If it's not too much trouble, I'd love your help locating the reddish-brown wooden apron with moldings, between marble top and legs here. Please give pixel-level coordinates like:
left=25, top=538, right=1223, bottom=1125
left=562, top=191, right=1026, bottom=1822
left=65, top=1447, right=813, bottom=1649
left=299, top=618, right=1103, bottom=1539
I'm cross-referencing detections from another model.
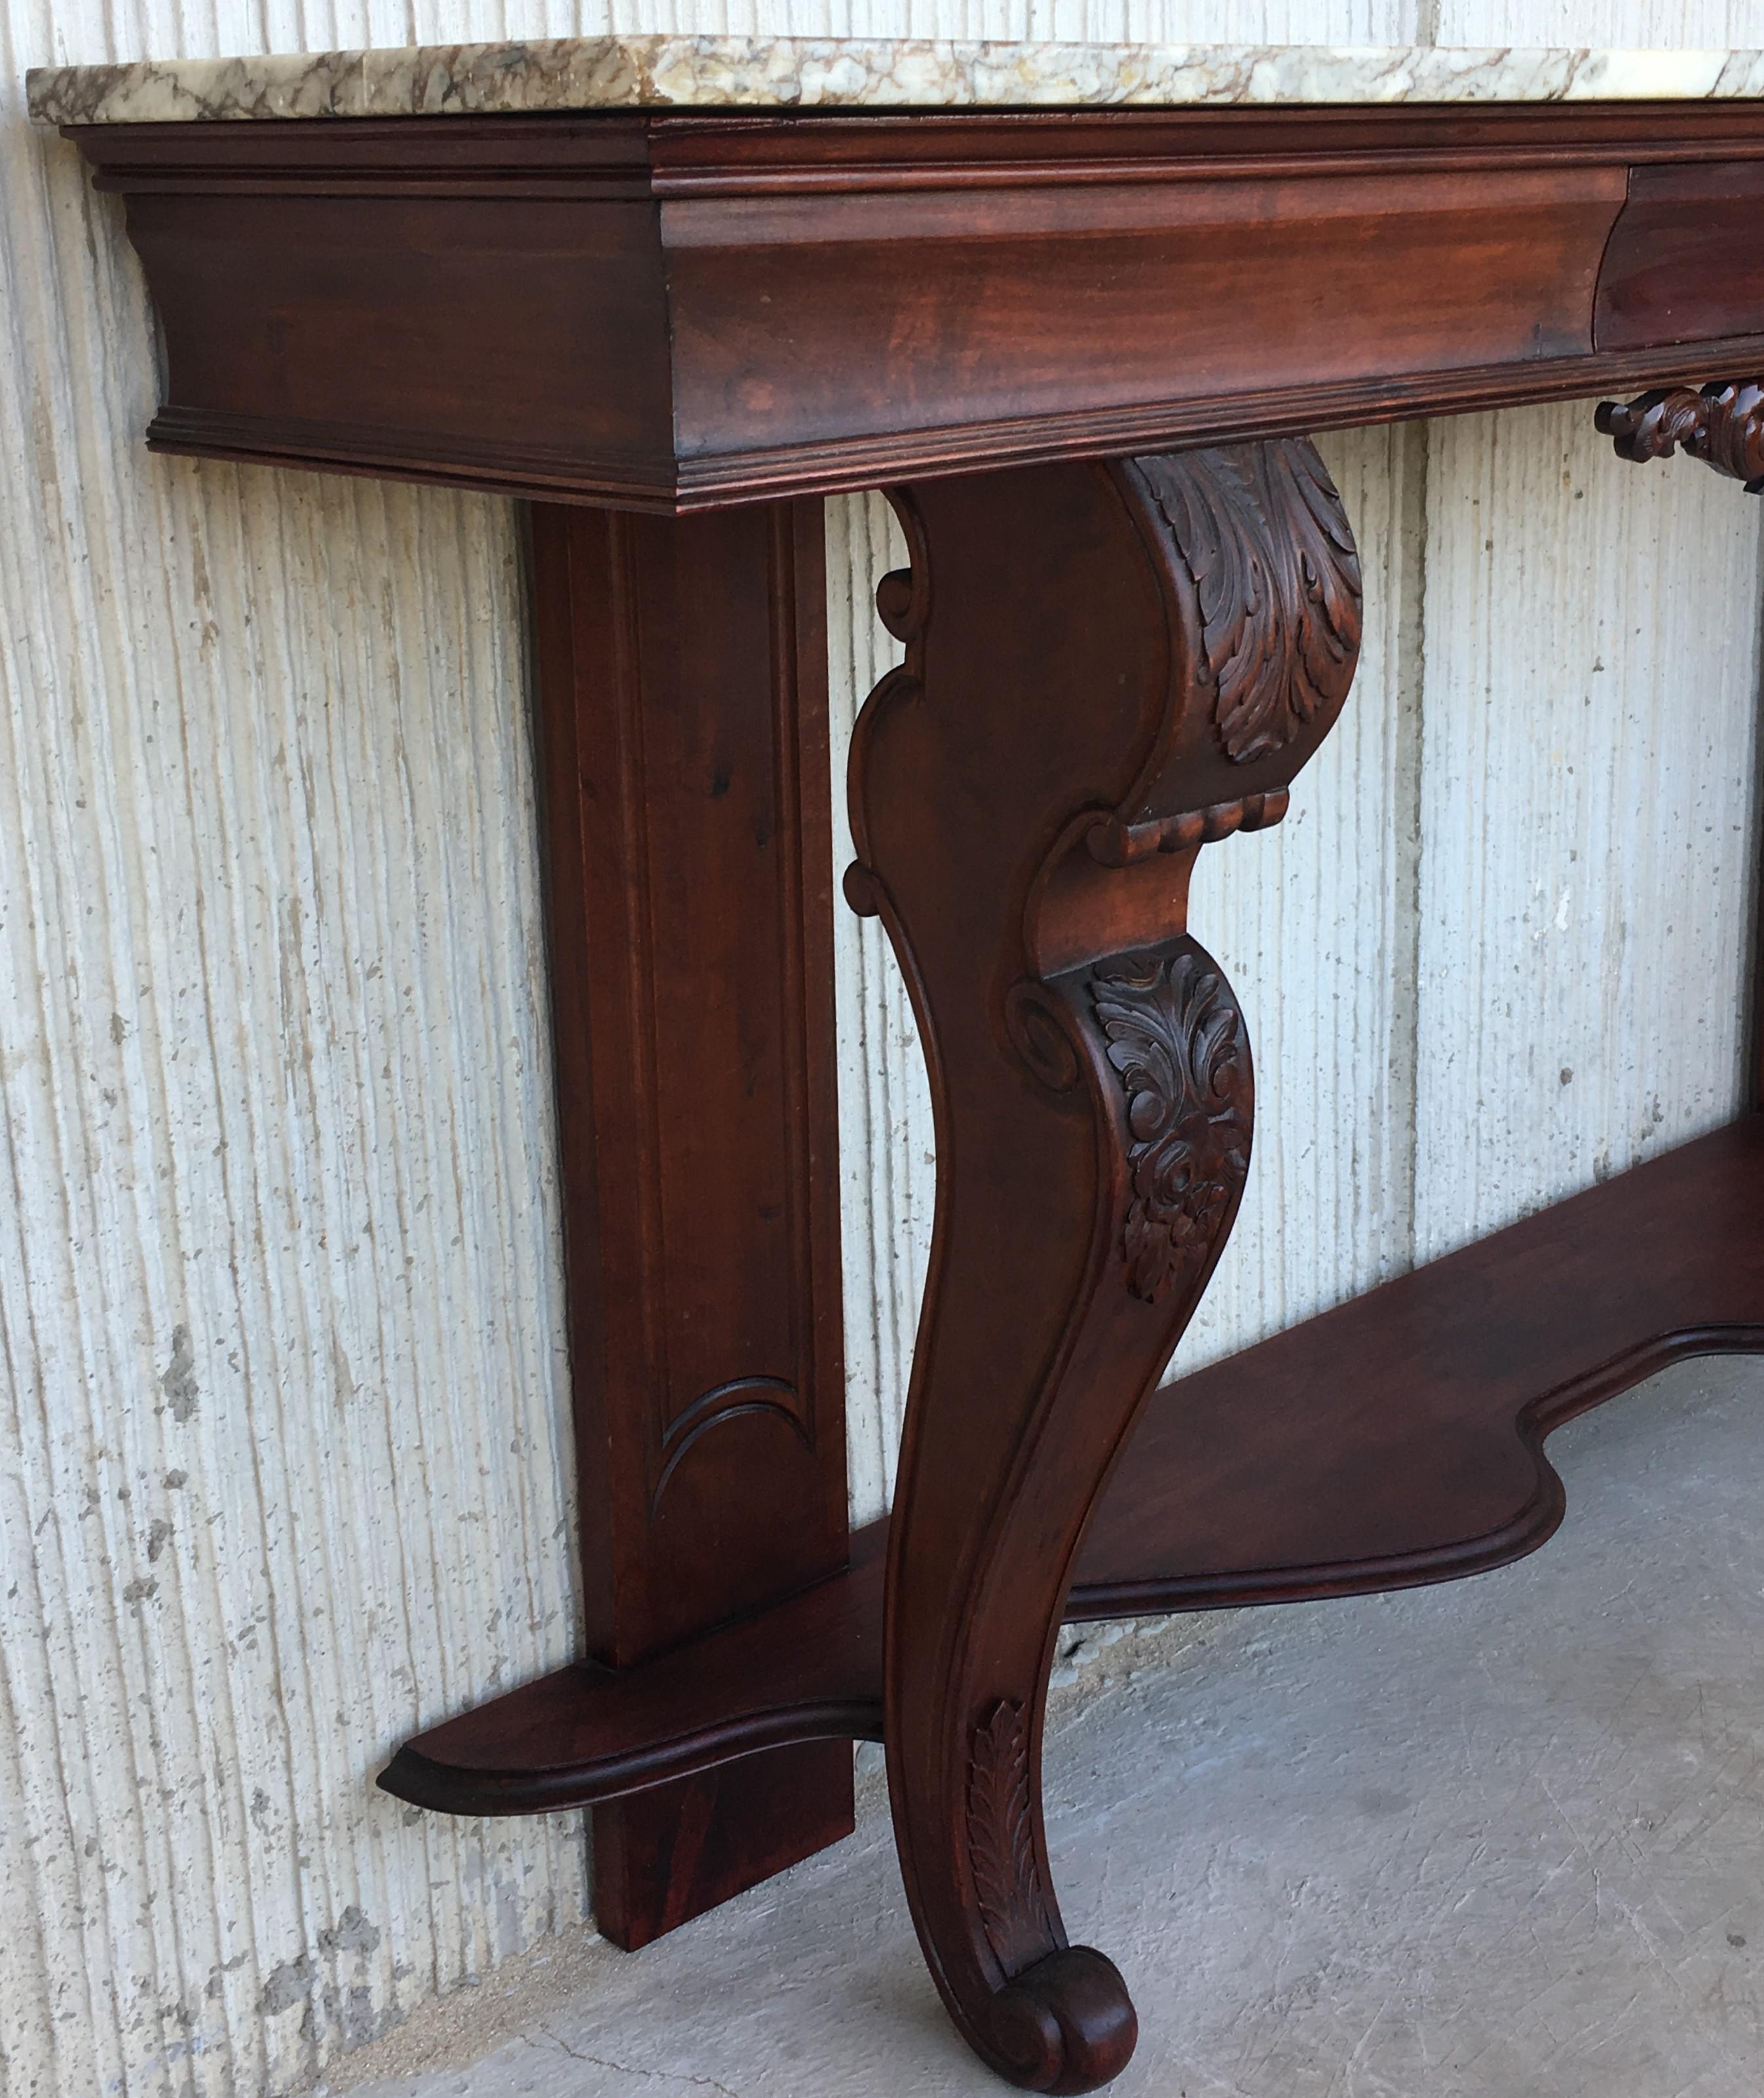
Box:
left=71, top=103, right=1764, bottom=508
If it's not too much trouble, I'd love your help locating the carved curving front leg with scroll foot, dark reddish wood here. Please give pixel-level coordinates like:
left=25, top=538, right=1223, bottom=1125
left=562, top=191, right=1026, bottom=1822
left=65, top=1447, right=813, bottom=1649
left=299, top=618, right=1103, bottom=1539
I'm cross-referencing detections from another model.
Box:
left=848, top=440, right=1359, bottom=2091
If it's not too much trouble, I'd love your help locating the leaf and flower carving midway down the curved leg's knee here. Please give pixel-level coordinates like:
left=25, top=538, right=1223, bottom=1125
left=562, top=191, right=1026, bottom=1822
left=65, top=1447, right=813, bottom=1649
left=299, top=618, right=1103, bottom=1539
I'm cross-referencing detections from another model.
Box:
left=1091, top=948, right=1250, bottom=1303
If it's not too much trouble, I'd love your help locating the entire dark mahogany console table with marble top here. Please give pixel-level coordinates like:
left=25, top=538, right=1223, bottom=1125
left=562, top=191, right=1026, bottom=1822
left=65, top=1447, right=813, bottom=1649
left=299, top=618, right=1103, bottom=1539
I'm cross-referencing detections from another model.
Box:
left=33, top=38, right=1764, bottom=2091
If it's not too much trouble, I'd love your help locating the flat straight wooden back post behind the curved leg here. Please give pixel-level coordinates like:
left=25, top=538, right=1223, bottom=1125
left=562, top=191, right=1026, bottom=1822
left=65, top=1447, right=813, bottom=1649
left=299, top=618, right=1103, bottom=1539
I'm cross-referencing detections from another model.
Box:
left=522, top=501, right=852, bottom=1945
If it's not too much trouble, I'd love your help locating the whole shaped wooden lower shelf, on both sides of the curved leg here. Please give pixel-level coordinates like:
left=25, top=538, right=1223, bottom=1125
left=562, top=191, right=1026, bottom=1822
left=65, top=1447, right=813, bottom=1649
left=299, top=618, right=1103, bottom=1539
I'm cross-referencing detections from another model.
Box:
left=380, top=1114, right=1764, bottom=1815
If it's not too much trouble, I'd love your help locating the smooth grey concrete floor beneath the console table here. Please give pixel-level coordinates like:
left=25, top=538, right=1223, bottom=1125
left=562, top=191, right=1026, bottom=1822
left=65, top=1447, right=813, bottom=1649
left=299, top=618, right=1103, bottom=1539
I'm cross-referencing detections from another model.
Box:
left=329, top=1362, right=1764, bottom=2098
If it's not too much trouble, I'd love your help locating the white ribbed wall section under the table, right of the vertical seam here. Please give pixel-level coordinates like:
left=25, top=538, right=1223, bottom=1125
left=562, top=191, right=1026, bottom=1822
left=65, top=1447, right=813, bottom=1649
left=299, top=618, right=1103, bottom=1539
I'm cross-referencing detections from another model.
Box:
left=1416, top=405, right=1760, bottom=1257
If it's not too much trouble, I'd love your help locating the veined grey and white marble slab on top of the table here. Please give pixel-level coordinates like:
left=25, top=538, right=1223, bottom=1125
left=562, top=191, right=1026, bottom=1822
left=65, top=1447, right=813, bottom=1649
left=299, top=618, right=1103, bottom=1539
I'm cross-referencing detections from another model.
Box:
left=29, top=35, right=1764, bottom=124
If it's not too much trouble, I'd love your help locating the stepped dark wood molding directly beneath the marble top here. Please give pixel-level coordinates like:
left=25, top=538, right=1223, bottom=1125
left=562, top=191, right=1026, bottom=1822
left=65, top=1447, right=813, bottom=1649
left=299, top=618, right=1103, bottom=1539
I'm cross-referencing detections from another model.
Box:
left=59, top=101, right=1764, bottom=201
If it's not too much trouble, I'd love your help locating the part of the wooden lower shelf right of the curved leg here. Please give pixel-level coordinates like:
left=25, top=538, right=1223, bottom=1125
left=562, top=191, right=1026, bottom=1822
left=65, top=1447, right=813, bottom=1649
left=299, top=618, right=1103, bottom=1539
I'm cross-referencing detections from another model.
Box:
left=1078, top=1116, right=1764, bottom=1616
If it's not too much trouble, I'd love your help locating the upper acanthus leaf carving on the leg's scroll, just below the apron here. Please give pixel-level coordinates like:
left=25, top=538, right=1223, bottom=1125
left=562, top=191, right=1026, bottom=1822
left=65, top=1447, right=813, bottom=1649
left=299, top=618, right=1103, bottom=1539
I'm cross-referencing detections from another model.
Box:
left=1137, top=436, right=1359, bottom=764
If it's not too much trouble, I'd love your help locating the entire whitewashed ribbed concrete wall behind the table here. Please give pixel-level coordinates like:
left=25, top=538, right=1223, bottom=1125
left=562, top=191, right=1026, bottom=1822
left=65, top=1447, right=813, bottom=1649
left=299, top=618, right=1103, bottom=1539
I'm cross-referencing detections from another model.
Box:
left=0, top=0, right=1760, bottom=2098
